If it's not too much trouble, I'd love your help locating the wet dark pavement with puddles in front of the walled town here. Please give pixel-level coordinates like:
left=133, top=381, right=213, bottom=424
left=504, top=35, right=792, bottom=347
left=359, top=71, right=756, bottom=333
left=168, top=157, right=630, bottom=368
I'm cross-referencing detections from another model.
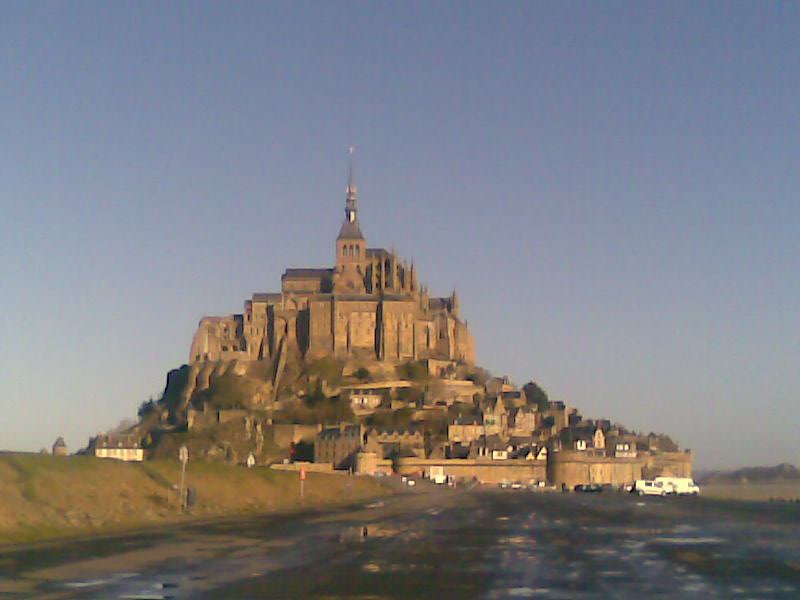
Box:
left=0, top=490, right=800, bottom=600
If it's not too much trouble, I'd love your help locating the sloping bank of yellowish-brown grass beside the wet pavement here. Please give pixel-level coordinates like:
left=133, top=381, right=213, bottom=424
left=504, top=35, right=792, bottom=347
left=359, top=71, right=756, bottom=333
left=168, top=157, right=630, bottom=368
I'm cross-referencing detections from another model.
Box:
left=0, top=454, right=388, bottom=544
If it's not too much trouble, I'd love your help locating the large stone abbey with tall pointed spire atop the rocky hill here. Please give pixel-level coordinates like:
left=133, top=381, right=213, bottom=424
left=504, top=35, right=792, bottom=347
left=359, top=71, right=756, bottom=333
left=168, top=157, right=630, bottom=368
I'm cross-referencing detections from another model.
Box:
left=189, top=168, right=474, bottom=363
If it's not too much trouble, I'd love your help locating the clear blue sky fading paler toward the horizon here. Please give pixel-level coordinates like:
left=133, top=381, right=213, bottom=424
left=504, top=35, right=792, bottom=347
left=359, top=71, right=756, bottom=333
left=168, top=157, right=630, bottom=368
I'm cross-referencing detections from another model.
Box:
left=0, top=2, right=800, bottom=467
